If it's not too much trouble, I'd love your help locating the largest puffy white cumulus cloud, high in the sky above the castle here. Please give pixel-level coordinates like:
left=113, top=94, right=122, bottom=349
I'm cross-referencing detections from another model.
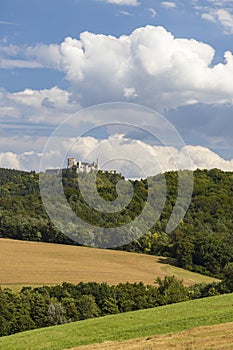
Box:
left=0, top=26, right=233, bottom=112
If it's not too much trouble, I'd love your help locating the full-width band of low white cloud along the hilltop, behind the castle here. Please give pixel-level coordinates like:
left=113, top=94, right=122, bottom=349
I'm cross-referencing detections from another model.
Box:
left=0, top=135, right=233, bottom=178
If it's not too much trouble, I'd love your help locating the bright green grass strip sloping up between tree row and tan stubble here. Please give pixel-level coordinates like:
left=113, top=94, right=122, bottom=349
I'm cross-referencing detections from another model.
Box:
left=0, top=294, right=233, bottom=350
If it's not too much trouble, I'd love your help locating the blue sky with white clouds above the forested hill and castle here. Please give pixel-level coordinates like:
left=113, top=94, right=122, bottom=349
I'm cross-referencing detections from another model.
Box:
left=0, top=0, right=233, bottom=177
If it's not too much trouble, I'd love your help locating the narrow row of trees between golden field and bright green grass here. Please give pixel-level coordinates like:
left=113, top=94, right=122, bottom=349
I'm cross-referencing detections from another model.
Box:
left=0, top=272, right=233, bottom=336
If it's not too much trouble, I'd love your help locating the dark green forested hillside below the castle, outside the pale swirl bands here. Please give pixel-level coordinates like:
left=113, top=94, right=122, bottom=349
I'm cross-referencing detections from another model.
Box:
left=0, top=169, right=233, bottom=277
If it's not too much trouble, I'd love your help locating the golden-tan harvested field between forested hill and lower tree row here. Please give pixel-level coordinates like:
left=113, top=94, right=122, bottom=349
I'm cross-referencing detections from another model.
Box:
left=0, top=239, right=217, bottom=289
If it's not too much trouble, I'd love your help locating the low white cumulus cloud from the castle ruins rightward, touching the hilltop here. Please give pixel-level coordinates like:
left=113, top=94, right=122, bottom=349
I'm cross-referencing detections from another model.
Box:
left=71, top=135, right=233, bottom=177
